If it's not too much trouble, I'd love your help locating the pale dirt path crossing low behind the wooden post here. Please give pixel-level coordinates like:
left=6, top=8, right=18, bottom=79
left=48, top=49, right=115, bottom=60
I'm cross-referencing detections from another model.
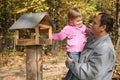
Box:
left=0, top=62, right=67, bottom=80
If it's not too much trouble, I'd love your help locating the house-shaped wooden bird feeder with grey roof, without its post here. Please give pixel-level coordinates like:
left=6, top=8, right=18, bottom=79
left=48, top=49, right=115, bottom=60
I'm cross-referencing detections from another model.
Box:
left=10, top=12, right=54, bottom=46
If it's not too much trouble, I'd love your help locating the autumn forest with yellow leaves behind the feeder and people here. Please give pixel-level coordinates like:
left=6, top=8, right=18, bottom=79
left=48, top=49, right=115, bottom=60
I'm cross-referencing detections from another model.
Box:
left=0, top=0, right=120, bottom=79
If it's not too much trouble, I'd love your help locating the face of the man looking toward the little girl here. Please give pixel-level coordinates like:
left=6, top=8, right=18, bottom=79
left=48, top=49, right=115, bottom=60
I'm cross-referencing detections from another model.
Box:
left=90, top=15, right=102, bottom=36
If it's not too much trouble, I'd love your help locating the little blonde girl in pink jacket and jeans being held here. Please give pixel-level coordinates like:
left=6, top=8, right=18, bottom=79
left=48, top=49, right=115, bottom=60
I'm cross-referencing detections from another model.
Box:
left=52, top=8, right=90, bottom=80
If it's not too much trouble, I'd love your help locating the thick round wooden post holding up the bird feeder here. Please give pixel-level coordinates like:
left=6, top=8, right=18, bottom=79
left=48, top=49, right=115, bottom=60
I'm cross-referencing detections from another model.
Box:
left=26, top=45, right=43, bottom=80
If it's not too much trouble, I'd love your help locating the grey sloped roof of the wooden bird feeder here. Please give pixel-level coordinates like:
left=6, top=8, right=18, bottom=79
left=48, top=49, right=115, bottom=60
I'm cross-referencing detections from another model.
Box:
left=10, top=12, right=53, bottom=29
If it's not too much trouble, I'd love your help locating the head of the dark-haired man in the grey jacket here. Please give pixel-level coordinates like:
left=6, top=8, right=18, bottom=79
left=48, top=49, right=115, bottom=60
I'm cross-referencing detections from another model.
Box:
left=91, top=13, right=114, bottom=38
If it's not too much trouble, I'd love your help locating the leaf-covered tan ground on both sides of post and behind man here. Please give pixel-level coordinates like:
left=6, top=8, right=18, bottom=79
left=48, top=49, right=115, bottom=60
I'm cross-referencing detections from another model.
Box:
left=0, top=50, right=120, bottom=80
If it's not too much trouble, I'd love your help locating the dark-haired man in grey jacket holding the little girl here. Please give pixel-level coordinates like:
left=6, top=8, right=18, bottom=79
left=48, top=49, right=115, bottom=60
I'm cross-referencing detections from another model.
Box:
left=66, top=13, right=115, bottom=80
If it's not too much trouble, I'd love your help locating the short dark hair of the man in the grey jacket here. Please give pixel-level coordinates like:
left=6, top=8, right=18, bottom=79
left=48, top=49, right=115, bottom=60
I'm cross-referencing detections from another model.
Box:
left=99, top=13, right=114, bottom=32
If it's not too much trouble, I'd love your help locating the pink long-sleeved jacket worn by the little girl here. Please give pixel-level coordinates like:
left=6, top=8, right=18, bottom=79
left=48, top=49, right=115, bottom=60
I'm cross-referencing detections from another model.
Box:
left=52, top=25, right=90, bottom=52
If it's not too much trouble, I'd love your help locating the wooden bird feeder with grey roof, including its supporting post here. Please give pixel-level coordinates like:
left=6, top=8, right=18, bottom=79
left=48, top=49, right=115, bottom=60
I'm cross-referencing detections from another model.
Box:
left=10, top=12, right=54, bottom=80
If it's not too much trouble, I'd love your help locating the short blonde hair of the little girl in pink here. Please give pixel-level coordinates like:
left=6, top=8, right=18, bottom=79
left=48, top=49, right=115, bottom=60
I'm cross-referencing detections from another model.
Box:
left=68, top=8, right=82, bottom=20
